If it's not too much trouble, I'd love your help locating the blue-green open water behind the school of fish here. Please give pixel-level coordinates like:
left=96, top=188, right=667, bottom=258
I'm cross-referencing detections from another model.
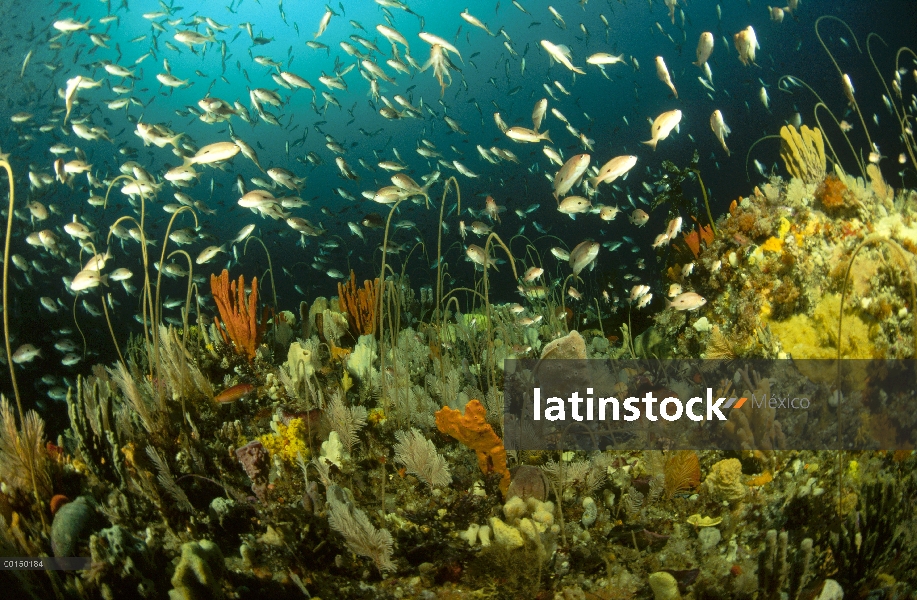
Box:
left=0, top=0, right=917, bottom=422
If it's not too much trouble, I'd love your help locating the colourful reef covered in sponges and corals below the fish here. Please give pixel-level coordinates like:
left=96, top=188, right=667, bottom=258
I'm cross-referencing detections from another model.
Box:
left=0, top=105, right=917, bottom=600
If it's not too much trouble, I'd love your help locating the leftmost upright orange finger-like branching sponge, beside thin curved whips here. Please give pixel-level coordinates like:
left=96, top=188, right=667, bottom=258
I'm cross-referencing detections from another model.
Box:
left=210, top=269, right=267, bottom=361
